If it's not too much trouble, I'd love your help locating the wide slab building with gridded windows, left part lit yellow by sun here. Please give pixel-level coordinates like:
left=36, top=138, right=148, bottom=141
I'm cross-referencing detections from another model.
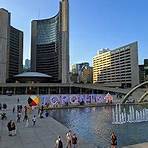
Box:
left=93, top=42, right=139, bottom=87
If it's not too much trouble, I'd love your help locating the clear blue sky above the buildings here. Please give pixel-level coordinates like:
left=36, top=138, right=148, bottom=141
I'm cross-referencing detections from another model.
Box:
left=0, top=0, right=148, bottom=64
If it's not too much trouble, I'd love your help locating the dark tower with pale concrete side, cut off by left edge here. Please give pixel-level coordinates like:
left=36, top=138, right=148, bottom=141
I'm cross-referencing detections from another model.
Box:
left=0, top=8, right=23, bottom=83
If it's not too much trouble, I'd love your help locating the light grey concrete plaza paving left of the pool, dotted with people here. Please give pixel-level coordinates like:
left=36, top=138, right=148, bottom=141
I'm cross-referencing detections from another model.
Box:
left=0, top=96, right=96, bottom=148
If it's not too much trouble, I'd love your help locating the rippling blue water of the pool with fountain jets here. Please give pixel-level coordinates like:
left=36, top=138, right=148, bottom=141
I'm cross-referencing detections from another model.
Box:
left=50, top=106, right=148, bottom=148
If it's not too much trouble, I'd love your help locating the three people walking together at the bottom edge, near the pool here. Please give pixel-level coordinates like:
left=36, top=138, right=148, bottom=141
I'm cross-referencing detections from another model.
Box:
left=56, top=130, right=78, bottom=148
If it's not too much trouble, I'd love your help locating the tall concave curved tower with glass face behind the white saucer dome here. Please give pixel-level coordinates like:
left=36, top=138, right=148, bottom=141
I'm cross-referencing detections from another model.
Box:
left=31, top=0, right=69, bottom=83
